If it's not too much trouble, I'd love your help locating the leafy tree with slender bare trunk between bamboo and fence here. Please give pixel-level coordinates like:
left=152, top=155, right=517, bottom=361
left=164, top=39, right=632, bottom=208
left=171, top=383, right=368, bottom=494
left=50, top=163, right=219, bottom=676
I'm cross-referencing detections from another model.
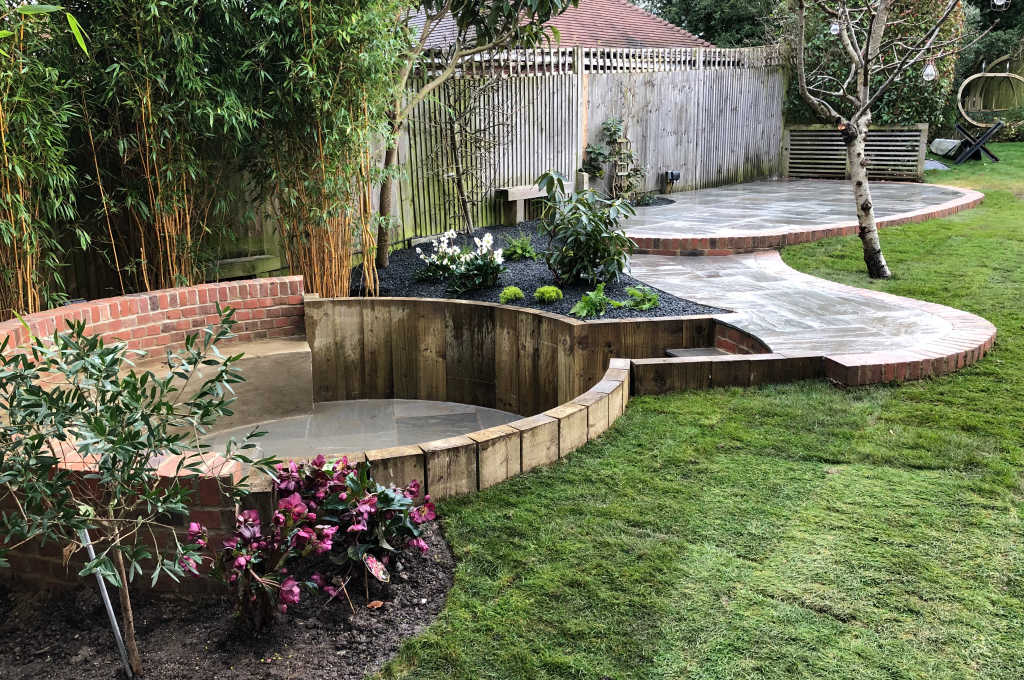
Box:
left=377, top=0, right=579, bottom=267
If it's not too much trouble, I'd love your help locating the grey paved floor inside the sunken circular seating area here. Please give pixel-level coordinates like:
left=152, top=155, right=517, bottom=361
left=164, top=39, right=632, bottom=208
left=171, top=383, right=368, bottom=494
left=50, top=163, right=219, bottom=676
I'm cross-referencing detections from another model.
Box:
left=210, top=399, right=522, bottom=459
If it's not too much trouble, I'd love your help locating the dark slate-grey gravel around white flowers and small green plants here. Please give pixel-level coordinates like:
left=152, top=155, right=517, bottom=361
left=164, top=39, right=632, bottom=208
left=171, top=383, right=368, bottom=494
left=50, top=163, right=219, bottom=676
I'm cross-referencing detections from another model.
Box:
left=352, top=222, right=723, bottom=318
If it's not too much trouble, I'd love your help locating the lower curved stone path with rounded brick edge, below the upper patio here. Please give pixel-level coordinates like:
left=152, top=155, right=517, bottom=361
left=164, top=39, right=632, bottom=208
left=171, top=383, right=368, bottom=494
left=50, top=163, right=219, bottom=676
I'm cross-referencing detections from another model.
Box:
left=631, top=251, right=995, bottom=384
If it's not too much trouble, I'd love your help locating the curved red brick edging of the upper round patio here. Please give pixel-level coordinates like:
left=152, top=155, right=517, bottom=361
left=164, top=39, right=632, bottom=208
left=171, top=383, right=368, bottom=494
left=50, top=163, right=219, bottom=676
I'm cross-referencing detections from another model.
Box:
left=627, top=182, right=985, bottom=256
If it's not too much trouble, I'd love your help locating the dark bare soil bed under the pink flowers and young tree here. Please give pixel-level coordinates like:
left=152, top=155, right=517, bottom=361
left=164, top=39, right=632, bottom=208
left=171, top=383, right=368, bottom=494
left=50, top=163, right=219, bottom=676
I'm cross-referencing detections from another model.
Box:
left=0, top=526, right=455, bottom=680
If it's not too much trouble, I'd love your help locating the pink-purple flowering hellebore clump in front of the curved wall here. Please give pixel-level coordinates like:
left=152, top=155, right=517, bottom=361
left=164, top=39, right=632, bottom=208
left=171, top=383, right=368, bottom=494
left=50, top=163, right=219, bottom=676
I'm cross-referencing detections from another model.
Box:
left=205, top=456, right=437, bottom=629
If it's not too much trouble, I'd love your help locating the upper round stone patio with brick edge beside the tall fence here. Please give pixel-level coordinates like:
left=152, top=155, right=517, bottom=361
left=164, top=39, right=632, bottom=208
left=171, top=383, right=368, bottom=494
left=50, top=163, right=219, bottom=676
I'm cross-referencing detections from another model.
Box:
left=626, top=179, right=984, bottom=255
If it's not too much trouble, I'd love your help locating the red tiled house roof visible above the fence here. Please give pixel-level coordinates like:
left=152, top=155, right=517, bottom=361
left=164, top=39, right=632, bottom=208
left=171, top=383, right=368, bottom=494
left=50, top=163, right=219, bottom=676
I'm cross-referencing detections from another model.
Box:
left=409, top=0, right=713, bottom=48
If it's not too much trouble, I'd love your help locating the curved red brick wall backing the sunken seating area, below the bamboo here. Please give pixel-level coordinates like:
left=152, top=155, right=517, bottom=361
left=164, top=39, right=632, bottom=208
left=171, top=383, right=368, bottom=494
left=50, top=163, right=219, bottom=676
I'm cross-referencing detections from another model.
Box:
left=0, top=277, right=305, bottom=351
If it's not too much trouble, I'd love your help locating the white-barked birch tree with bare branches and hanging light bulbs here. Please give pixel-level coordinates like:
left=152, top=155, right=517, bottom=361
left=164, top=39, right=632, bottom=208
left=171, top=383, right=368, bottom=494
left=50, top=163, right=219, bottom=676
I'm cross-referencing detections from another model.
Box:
left=793, top=0, right=962, bottom=279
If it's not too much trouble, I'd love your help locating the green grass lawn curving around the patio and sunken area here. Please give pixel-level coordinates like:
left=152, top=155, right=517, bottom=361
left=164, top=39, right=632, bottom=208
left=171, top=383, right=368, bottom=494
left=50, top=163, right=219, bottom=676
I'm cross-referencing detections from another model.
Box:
left=383, top=144, right=1024, bottom=680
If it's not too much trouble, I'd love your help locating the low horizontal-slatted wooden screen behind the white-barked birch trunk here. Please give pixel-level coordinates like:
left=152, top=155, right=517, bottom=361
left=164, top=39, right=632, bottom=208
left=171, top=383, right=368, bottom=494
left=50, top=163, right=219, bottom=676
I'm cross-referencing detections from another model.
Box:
left=783, top=124, right=928, bottom=180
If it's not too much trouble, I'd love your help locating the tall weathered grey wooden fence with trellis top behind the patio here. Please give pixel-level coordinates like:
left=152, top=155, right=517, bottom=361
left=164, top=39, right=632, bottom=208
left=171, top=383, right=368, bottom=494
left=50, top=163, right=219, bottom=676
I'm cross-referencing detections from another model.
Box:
left=393, top=47, right=784, bottom=241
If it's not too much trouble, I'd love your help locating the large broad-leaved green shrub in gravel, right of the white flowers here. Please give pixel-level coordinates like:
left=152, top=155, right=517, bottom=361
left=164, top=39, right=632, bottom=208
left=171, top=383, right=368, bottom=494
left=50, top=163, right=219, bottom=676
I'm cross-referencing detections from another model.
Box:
left=537, top=171, right=636, bottom=286
